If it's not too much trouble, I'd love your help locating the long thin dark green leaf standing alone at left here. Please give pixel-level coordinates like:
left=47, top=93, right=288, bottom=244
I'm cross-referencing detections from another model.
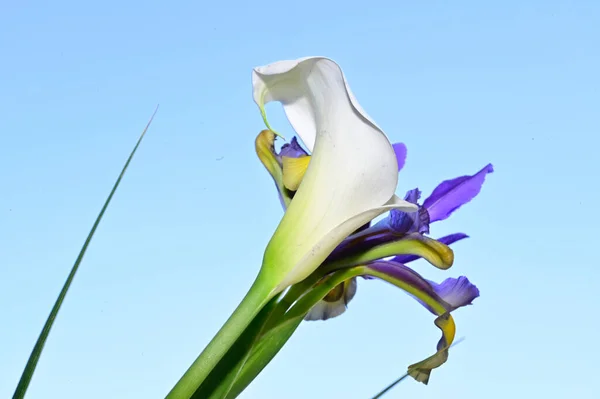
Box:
left=13, top=106, right=158, bottom=399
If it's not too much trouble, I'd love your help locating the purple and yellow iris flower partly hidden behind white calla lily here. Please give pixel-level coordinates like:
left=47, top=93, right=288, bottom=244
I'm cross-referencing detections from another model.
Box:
left=257, top=132, right=494, bottom=383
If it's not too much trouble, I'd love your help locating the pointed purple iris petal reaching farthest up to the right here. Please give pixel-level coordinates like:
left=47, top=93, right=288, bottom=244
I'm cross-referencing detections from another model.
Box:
left=423, top=164, right=494, bottom=223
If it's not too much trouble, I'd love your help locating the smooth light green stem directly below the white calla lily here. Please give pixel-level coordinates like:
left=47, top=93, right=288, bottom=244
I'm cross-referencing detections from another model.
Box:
left=166, top=275, right=275, bottom=399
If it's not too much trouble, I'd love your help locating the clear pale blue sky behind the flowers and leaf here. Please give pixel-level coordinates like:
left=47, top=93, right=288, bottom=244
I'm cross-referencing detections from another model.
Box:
left=0, top=0, right=600, bottom=399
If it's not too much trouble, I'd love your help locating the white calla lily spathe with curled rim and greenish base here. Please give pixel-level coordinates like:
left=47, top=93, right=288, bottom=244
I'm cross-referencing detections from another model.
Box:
left=252, top=57, right=417, bottom=292
